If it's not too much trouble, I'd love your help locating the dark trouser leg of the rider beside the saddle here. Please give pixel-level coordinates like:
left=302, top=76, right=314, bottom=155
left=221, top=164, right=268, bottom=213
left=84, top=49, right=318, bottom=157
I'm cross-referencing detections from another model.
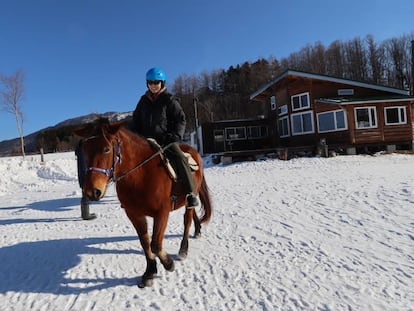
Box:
left=165, top=143, right=194, bottom=194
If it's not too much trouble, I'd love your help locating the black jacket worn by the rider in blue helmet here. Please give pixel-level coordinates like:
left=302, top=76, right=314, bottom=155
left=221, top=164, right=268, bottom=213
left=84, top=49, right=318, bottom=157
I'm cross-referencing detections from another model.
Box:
left=132, top=92, right=186, bottom=145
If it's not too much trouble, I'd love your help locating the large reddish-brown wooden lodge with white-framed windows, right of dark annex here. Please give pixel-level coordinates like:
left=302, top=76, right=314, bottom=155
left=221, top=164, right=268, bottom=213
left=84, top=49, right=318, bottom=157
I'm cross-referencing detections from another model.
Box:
left=250, top=70, right=414, bottom=154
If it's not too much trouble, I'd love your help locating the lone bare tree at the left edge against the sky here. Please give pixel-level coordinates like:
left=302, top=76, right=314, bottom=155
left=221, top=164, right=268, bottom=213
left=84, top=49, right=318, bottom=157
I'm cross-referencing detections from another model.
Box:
left=0, top=69, right=25, bottom=158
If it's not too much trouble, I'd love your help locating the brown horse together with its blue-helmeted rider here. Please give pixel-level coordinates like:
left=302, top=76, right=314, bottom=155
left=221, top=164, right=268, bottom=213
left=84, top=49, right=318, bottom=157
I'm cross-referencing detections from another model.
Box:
left=75, top=68, right=212, bottom=287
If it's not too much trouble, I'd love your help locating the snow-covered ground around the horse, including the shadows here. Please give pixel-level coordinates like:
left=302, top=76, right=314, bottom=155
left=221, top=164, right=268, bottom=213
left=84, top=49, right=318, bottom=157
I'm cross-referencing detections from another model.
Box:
left=0, top=152, right=414, bottom=311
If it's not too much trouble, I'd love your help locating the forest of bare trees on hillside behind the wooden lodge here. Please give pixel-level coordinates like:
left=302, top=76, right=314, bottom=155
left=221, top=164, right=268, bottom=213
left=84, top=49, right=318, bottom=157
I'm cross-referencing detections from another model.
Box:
left=173, top=32, right=414, bottom=130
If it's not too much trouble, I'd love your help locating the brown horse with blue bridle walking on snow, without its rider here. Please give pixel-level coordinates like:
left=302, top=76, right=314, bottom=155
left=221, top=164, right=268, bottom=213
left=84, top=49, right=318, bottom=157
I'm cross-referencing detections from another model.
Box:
left=75, top=118, right=212, bottom=287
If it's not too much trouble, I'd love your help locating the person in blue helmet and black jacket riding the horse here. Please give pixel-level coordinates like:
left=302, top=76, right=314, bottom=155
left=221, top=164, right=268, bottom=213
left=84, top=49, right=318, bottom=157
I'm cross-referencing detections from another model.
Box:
left=132, top=67, right=199, bottom=208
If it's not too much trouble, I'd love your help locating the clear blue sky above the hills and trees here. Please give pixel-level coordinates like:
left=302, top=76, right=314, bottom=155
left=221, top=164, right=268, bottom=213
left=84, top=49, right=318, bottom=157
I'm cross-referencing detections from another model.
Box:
left=0, top=0, right=414, bottom=141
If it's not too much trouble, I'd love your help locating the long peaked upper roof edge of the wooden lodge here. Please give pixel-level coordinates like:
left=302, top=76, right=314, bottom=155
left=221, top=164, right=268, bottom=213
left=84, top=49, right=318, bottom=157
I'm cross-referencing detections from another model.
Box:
left=250, top=69, right=409, bottom=100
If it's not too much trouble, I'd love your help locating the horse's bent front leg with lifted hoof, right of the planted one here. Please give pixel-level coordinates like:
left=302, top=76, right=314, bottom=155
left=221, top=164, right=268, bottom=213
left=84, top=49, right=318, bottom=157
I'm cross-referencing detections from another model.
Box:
left=151, top=210, right=174, bottom=271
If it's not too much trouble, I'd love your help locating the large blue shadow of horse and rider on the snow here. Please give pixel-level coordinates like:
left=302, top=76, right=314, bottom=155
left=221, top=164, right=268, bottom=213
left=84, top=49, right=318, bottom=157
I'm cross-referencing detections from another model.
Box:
left=0, top=236, right=143, bottom=295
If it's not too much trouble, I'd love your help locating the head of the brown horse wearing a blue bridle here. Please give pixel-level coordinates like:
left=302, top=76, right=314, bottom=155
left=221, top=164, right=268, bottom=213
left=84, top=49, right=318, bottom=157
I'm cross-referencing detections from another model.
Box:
left=74, top=117, right=124, bottom=201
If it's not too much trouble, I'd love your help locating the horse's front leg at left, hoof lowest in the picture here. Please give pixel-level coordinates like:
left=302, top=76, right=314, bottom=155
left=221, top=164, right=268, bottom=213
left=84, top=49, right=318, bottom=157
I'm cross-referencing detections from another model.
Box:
left=126, top=210, right=158, bottom=288
